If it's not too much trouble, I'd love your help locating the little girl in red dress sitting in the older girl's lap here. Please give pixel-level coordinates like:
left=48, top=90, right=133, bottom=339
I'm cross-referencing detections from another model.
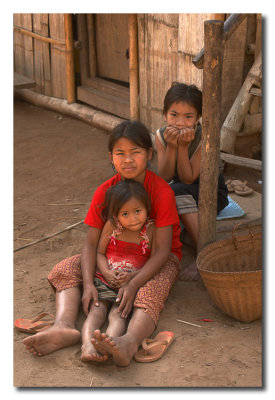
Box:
left=82, top=180, right=155, bottom=361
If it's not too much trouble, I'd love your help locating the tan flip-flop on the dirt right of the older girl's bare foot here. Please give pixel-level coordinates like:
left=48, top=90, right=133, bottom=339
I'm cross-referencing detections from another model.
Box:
left=135, top=331, right=174, bottom=362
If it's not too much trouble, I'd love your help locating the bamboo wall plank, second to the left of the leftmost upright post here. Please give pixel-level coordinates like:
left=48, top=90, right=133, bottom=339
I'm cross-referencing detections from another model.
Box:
left=33, top=14, right=52, bottom=96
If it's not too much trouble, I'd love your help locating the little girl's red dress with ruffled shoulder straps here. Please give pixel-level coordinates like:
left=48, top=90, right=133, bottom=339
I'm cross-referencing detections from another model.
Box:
left=95, top=220, right=153, bottom=287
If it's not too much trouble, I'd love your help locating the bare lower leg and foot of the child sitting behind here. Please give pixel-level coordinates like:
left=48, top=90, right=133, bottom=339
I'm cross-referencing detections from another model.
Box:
left=179, top=212, right=199, bottom=281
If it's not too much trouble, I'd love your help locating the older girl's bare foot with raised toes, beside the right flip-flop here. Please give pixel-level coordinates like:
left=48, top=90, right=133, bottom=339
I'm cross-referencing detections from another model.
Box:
left=91, top=329, right=138, bottom=367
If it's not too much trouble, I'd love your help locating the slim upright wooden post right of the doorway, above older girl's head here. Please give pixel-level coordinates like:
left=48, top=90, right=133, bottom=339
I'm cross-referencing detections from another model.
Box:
left=128, top=14, right=139, bottom=120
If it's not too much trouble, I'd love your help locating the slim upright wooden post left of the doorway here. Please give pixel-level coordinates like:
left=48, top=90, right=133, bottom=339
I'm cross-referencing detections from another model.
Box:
left=64, top=14, right=76, bottom=104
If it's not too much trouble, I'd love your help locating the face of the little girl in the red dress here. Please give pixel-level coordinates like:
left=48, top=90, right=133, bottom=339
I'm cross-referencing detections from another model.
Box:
left=117, top=198, right=147, bottom=231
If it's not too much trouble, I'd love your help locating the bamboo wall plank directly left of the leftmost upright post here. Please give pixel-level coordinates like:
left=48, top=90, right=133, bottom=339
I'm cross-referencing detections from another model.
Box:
left=49, top=14, right=67, bottom=99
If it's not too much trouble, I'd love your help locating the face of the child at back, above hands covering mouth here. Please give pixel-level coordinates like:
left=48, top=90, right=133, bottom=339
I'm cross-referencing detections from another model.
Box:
left=164, top=101, right=200, bottom=129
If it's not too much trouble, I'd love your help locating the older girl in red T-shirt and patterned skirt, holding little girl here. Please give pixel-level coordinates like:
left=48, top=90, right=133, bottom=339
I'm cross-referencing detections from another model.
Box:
left=23, top=121, right=182, bottom=366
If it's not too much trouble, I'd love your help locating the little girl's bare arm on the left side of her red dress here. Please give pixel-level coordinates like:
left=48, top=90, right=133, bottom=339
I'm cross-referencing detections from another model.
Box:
left=97, top=221, right=121, bottom=285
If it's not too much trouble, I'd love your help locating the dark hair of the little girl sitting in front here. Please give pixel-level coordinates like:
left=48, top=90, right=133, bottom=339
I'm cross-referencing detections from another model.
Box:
left=102, top=179, right=151, bottom=225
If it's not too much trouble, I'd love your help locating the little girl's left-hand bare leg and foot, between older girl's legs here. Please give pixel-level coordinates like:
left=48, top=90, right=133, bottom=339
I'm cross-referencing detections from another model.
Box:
left=81, top=301, right=109, bottom=362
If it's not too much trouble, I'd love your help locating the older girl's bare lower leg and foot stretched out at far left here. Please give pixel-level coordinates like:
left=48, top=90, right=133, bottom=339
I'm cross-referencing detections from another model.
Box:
left=23, top=287, right=81, bottom=356
